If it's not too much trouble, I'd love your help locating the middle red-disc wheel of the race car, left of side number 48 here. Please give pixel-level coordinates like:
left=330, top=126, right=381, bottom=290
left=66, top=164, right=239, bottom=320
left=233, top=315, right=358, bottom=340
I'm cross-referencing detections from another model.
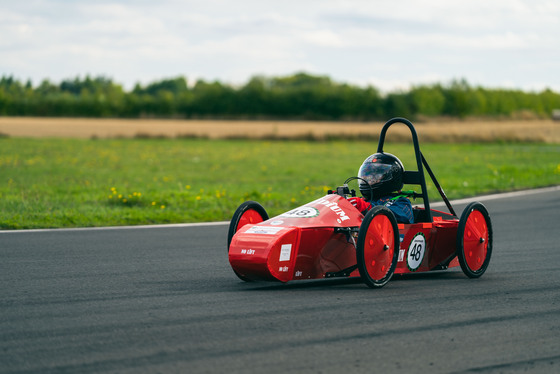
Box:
left=356, top=206, right=400, bottom=288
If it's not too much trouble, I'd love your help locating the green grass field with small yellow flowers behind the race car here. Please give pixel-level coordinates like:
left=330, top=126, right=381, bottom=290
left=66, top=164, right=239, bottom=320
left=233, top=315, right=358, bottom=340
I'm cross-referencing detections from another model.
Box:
left=0, top=138, right=560, bottom=229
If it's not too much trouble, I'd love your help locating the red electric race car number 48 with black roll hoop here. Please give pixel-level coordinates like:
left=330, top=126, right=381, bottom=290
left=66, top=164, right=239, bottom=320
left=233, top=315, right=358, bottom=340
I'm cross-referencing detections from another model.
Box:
left=228, top=118, right=492, bottom=288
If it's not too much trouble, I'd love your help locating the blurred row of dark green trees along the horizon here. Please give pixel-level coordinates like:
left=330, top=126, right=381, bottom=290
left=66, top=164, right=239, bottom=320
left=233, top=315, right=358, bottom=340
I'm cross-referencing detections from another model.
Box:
left=0, top=73, right=560, bottom=121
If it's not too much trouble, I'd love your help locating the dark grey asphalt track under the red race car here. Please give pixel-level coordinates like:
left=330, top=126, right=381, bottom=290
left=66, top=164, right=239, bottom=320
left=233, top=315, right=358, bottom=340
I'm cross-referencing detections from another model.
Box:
left=0, top=188, right=560, bottom=373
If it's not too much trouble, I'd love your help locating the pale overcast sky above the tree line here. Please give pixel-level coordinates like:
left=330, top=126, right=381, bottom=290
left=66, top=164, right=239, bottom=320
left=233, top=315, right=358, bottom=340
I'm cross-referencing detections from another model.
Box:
left=0, top=0, right=560, bottom=91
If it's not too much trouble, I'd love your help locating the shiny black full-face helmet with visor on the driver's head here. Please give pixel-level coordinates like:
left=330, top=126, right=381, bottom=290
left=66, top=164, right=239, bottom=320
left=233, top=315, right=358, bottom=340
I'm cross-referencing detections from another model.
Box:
left=358, top=153, right=404, bottom=200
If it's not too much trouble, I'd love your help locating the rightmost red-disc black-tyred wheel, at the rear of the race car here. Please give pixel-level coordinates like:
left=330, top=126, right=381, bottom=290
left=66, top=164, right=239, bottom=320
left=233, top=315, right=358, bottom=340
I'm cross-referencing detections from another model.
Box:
left=457, top=202, right=492, bottom=278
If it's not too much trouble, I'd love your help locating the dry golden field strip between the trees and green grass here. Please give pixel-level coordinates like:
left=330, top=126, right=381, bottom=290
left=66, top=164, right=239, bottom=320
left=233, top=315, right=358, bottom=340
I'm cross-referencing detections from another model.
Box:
left=0, top=117, right=560, bottom=143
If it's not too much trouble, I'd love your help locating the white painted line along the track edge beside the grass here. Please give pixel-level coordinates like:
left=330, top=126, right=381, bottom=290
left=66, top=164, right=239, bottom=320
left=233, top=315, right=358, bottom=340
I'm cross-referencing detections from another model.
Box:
left=0, top=185, right=560, bottom=234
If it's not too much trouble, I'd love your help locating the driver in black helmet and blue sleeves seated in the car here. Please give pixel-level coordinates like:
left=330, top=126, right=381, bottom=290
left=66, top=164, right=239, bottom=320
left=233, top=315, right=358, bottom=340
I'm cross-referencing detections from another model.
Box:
left=348, top=153, right=414, bottom=223
